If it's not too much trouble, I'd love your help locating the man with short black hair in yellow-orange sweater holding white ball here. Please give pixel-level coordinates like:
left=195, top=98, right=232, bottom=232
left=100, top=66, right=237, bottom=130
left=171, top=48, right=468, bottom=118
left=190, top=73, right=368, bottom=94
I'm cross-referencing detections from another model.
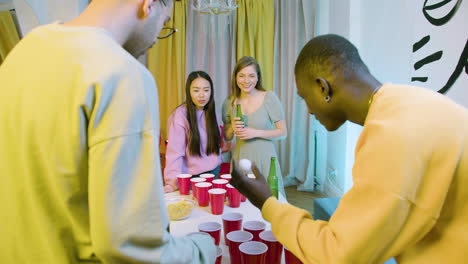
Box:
left=231, top=35, right=468, bottom=264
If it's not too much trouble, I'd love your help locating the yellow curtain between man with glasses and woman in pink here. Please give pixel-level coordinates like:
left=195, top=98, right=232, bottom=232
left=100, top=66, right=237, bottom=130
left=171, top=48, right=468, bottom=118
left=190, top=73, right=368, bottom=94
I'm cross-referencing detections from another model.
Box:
left=147, top=0, right=187, bottom=144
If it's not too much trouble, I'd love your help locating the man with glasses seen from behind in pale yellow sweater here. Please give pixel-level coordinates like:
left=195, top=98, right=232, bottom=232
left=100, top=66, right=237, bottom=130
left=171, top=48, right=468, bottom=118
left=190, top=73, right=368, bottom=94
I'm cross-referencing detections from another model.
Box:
left=0, top=0, right=216, bottom=264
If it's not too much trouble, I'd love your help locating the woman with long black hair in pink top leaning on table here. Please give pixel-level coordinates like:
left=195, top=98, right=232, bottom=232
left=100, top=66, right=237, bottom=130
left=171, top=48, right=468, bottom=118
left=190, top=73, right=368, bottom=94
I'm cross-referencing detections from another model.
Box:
left=164, top=71, right=222, bottom=192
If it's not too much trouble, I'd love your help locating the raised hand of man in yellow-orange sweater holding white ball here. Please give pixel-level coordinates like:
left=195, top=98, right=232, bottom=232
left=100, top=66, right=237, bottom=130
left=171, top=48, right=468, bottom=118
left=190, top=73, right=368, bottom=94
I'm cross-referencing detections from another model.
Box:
left=229, top=159, right=272, bottom=210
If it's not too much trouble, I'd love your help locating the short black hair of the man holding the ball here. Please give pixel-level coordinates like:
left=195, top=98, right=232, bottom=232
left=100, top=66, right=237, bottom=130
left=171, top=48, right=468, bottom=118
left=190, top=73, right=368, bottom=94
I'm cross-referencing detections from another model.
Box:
left=294, top=34, right=369, bottom=78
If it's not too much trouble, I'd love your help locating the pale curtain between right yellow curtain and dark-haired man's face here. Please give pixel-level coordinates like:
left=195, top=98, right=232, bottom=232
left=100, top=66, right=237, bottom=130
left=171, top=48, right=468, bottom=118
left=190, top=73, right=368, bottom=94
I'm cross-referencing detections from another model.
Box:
left=274, top=0, right=327, bottom=191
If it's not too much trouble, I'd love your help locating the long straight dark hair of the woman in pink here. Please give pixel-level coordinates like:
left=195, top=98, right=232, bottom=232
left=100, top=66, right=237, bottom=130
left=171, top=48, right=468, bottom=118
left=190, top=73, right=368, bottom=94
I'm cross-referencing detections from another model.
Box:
left=185, top=71, right=221, bottom=156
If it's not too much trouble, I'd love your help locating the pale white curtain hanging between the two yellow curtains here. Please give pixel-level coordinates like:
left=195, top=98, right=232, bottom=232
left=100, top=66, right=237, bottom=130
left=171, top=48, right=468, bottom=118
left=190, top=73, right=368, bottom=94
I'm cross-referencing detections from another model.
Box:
left=185, top=0, right=236, bottom=119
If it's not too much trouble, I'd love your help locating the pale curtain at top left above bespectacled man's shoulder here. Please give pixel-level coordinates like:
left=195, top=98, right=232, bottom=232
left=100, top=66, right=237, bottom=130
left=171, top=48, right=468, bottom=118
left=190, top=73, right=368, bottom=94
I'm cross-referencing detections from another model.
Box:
left=13, top=0, right=89, bottom=36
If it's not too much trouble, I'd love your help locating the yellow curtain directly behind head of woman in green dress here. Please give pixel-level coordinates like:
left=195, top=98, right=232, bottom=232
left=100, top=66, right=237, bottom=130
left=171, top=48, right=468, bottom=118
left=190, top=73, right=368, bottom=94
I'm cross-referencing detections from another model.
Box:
left=236, top=0, right=275, bottom=90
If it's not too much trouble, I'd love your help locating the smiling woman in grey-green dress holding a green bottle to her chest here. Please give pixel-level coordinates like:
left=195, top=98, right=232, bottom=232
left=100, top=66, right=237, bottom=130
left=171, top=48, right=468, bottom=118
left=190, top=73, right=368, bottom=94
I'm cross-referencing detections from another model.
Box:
left=222, top=56, right=287, bottom=195
